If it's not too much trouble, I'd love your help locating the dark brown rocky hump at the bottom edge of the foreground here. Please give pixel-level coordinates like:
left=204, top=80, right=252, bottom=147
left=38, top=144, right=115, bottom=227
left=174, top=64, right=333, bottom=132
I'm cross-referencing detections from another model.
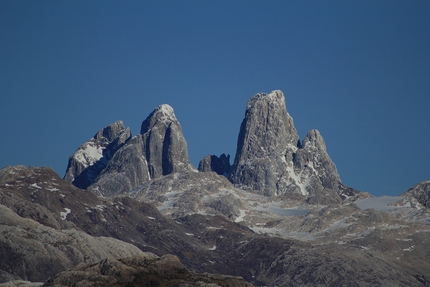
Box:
left=44, top=253, right=254, bottom=287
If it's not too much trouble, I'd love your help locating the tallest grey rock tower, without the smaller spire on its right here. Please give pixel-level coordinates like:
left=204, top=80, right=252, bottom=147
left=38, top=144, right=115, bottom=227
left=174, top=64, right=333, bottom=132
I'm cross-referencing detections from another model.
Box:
left=229, top=91, right=300, bottom=196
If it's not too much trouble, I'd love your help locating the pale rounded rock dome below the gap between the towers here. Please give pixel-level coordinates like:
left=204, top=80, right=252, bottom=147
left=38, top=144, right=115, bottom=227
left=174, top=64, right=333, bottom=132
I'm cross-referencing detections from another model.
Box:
left=130, top=172, right=245, bottom=220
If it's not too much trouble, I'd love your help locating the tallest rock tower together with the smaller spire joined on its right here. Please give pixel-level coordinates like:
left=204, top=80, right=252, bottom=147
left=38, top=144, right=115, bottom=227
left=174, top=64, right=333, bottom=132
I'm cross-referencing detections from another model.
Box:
left=229, top=90, right=347, bottom=201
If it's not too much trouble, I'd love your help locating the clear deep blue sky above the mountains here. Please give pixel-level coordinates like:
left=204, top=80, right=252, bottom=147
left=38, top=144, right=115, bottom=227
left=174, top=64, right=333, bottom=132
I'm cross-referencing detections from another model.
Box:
left=0, top=0, right=430, bottom=195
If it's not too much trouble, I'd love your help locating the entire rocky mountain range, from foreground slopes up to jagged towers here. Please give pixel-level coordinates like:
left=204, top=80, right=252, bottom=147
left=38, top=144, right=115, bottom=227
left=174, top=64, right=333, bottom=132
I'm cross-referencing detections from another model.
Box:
left=0, top=90, right=430, bottom=286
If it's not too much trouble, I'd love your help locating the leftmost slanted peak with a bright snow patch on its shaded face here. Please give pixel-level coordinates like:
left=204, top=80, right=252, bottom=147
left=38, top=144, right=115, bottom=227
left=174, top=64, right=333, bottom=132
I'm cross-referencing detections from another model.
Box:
left=64, top=121, right=131, bottom=189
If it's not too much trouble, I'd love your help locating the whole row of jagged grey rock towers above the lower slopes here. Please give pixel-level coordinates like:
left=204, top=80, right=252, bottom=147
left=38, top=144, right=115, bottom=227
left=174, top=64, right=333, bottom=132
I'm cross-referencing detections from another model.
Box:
left=65, top=90, right=355, bottom=203
